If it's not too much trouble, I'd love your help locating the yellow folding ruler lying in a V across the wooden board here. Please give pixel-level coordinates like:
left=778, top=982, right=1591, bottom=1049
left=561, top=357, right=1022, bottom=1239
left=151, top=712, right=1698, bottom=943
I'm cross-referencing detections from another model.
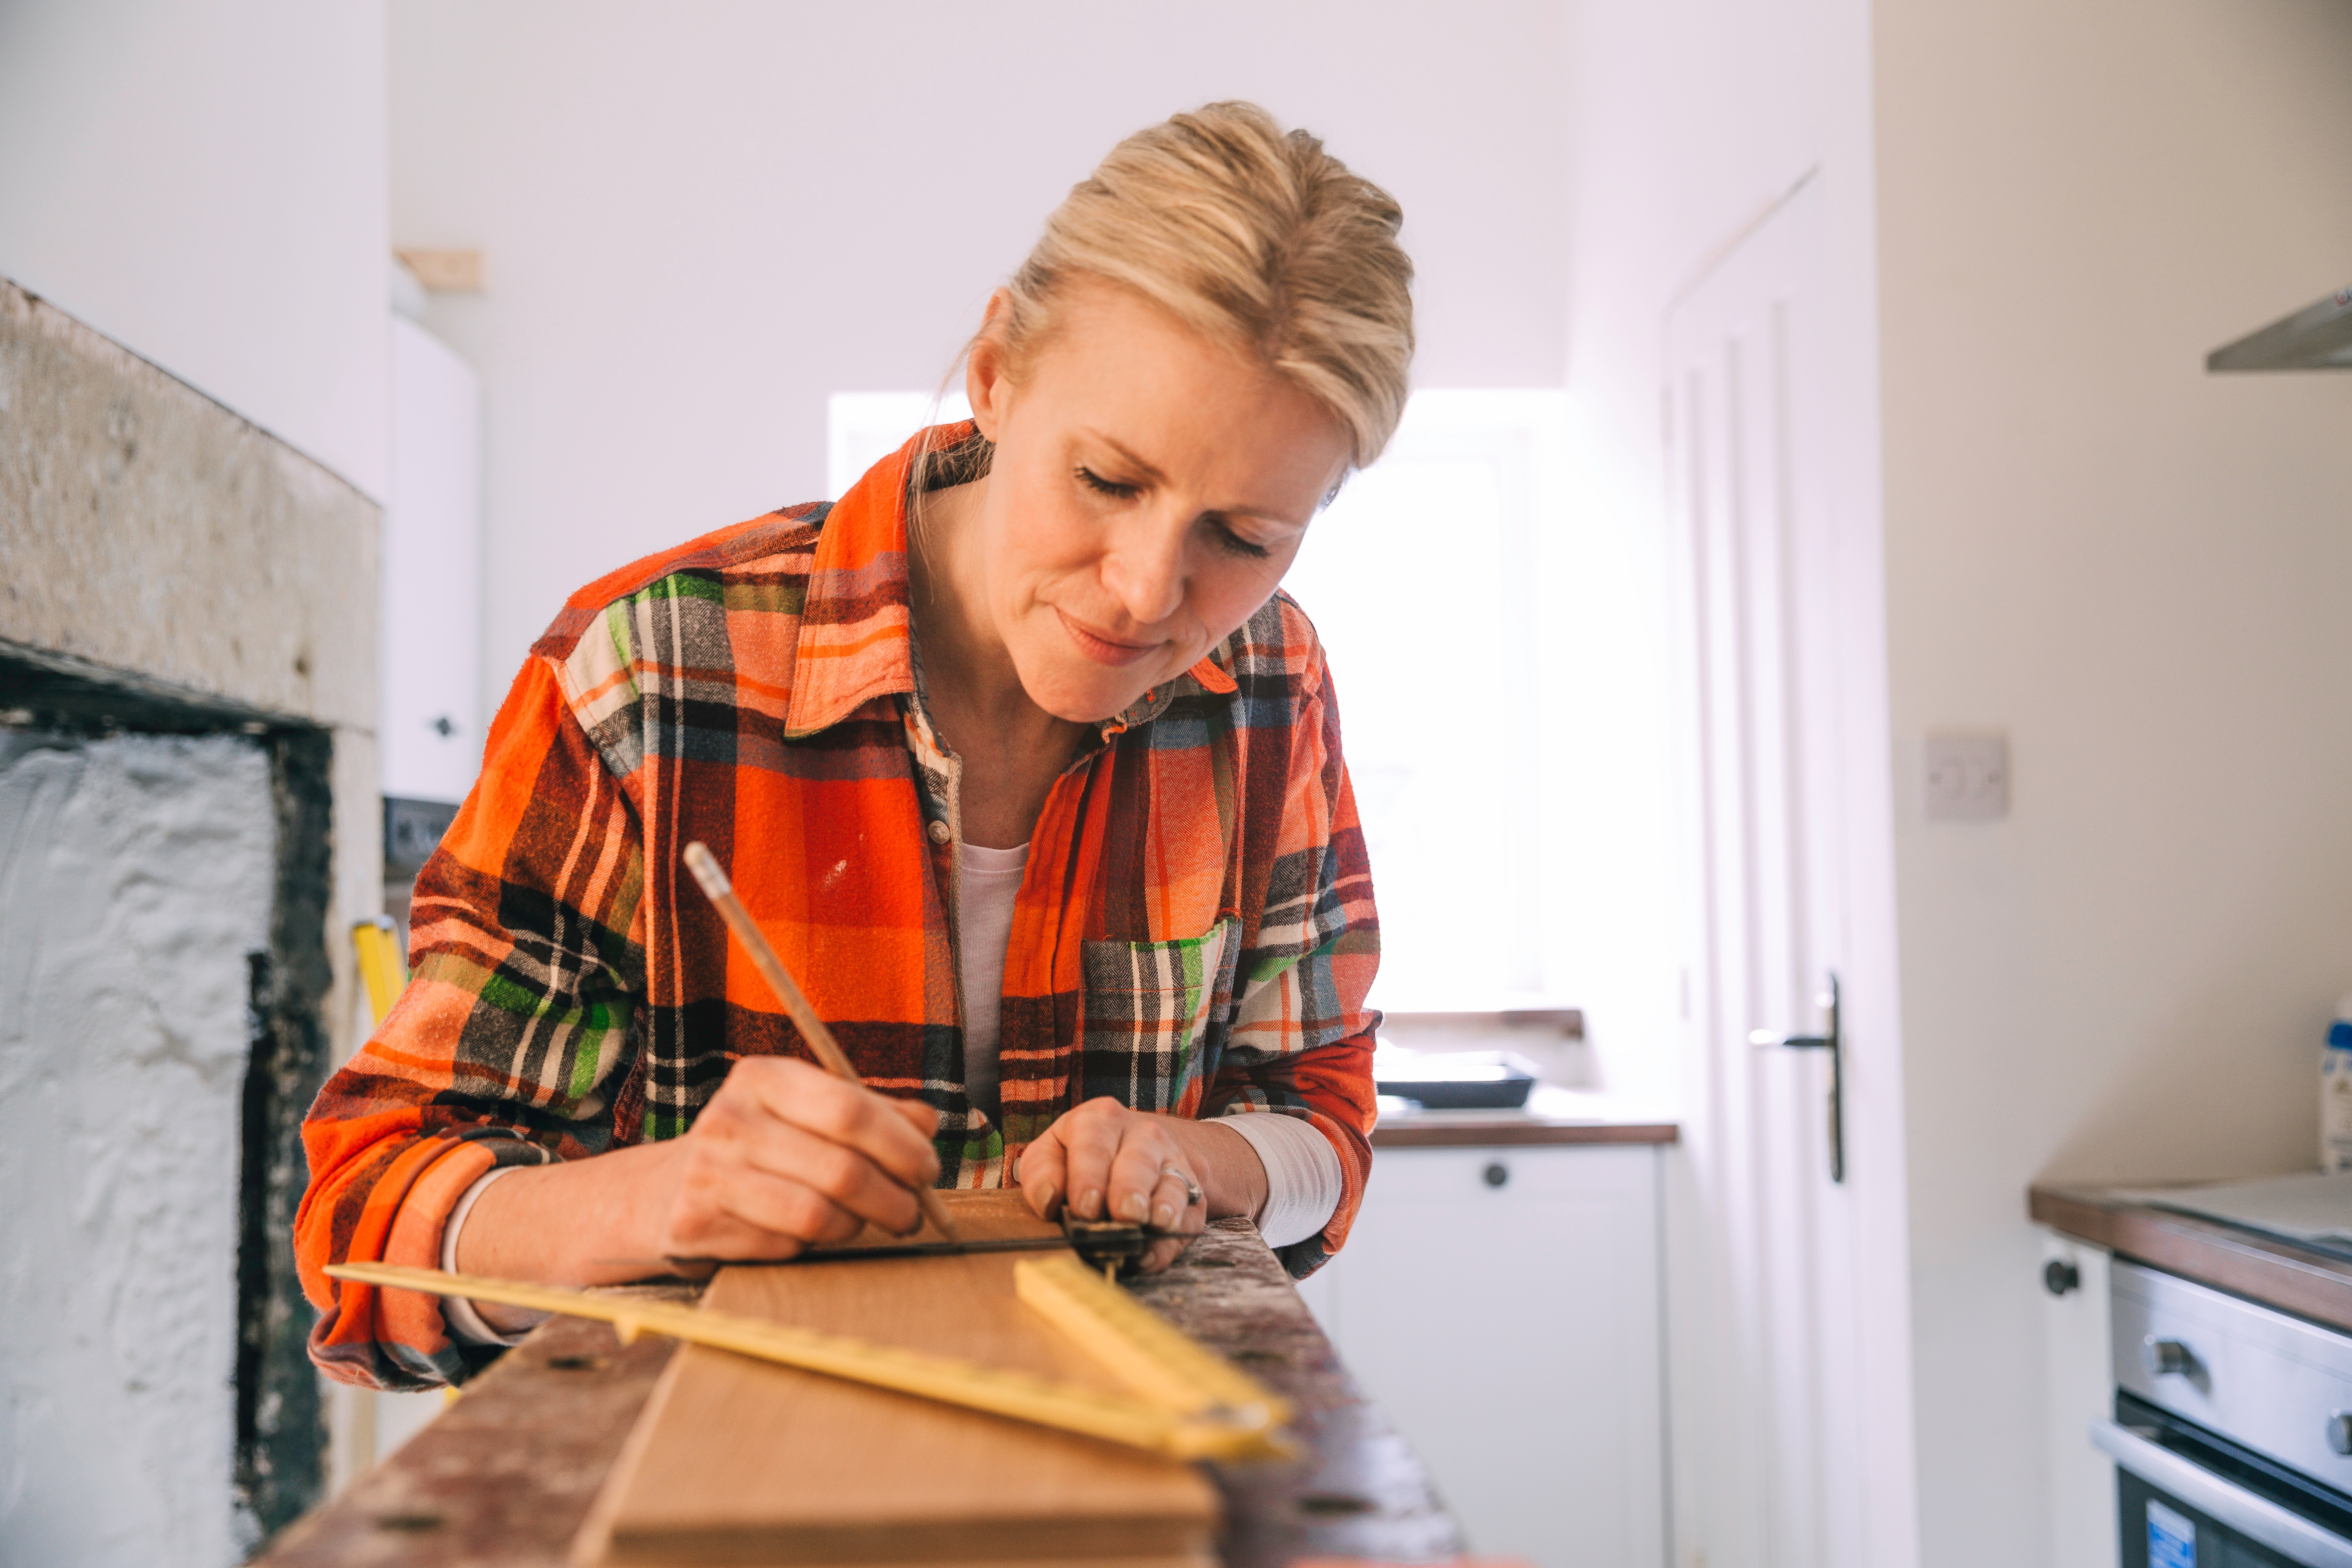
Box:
left=327, top=1255, right=1298, bottom=1460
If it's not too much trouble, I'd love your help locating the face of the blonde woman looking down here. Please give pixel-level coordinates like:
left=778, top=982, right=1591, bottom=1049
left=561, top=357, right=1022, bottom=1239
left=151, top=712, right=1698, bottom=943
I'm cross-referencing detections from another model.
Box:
left=967, top=280, right=1348, bottom=724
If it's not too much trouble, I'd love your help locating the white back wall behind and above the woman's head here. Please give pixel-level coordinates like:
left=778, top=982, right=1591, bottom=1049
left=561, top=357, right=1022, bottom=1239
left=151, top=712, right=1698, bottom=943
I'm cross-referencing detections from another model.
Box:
left=391, top=0, right=1564, bottom=698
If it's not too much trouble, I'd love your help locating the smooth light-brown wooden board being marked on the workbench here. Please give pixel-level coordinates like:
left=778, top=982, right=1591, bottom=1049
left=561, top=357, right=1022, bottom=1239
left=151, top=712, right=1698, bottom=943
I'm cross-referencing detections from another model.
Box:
left=574, top=1192, right=1218, bottom=1568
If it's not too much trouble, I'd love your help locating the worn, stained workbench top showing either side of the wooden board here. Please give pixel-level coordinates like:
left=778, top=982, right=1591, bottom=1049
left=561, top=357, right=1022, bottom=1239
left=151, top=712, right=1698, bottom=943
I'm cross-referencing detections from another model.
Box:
left=259, top=1220, right=1463, bottom=1568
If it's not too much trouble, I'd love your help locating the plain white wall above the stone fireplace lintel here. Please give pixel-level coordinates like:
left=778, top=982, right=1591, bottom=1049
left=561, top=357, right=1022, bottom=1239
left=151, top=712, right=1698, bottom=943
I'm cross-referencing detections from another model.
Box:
left=0, top=0, right=388, bottom=501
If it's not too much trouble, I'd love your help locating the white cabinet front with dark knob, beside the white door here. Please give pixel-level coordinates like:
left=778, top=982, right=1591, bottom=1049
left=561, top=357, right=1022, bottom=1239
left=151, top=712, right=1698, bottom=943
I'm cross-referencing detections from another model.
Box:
left=1301, top=1145, right=1665, bottom=1568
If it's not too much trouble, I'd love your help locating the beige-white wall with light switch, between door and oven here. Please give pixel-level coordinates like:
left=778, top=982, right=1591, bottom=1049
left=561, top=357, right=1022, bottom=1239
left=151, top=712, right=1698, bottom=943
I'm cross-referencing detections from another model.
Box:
left=1877, top=0, right=2352, bottom=1568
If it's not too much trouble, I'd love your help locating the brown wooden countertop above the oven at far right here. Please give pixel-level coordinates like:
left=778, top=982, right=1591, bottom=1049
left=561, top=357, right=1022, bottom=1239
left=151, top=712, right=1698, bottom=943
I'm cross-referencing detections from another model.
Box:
left=2025, top=1187, right=2352, bottom=1333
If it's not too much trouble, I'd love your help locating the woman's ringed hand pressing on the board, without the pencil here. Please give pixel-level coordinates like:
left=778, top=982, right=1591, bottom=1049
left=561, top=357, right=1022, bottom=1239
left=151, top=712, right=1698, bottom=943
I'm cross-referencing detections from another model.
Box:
left=1016, top=1096, right=1265, bottom=1274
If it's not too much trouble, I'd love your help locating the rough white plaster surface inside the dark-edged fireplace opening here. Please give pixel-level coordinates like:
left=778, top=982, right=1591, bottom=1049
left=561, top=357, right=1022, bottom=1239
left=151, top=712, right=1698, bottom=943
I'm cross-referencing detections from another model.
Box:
left=0, top=734, right=275, bottom=1568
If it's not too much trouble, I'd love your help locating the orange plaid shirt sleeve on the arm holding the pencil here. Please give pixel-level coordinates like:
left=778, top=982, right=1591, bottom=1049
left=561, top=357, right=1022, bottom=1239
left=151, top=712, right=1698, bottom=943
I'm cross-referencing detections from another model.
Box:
left=294, top=656, right=644, bottom=1389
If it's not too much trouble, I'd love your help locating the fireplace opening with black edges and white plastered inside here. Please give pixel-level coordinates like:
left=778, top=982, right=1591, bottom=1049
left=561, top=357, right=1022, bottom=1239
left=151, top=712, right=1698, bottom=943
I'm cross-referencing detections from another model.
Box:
left=0, top=644, right=334, bottom=1561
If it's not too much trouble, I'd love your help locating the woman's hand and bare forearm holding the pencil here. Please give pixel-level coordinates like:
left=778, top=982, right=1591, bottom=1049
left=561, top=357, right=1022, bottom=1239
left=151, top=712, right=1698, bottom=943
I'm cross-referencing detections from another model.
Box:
left=459, top=1055, right=938, bottom=1286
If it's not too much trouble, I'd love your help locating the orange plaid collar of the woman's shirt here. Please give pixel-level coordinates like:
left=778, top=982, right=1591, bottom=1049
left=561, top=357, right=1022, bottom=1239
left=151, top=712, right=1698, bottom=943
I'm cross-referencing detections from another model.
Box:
left=783, top=418, right=1237, bottom=740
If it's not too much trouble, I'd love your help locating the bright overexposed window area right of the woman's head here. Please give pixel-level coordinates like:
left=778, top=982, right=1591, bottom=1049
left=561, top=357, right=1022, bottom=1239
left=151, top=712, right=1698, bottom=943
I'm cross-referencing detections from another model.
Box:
left=1282, top=390, right=1562, bottom=1013
